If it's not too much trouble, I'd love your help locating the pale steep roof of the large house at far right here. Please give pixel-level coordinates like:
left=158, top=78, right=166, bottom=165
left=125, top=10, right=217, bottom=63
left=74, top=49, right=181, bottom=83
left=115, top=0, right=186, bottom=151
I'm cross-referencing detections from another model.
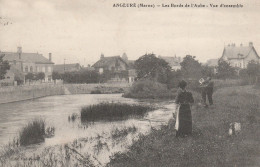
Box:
left=222, top=46, right=259, bottom=59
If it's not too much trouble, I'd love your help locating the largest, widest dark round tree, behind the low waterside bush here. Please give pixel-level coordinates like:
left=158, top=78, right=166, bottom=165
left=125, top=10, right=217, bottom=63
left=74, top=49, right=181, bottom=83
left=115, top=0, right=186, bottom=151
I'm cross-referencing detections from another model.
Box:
left=135, top=54, right=171, bottom=83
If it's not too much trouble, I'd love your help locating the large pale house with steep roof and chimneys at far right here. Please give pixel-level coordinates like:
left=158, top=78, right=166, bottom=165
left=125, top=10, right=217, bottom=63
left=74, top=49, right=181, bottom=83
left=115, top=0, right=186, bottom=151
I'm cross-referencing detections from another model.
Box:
left=220, top=42, right=260, bottom=69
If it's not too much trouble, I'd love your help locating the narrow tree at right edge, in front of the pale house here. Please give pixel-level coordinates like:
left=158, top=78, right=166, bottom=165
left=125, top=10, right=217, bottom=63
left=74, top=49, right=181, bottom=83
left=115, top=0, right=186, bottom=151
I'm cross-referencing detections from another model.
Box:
left=247, top=60, right=260, bottom=84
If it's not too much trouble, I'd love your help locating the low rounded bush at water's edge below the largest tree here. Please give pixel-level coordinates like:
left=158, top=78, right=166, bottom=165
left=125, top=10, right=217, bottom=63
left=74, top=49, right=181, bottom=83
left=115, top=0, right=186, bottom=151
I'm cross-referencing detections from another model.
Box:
left=123, top=79, right=177, bottom=99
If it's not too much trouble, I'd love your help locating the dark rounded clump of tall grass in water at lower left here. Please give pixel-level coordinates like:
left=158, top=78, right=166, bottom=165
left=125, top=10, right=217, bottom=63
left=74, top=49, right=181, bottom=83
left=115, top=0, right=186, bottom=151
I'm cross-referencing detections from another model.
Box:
left=19, top=119, right=45, bottom=146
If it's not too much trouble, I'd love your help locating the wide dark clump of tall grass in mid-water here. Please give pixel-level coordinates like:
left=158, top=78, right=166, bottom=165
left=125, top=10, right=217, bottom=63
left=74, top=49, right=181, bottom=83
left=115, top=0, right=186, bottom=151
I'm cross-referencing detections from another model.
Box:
left=81, top=103, right=153, bottom=122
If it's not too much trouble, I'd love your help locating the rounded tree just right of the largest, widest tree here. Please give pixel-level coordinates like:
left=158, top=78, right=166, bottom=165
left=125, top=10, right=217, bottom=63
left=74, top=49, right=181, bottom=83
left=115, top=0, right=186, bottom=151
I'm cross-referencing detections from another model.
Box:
left=180, top=55, right=202, bottom=79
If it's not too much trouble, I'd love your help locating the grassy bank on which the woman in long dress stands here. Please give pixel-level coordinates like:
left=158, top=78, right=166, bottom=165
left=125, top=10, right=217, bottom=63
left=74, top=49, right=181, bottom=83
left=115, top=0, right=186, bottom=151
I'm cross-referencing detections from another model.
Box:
left=108, top=86, right=260, bottom=167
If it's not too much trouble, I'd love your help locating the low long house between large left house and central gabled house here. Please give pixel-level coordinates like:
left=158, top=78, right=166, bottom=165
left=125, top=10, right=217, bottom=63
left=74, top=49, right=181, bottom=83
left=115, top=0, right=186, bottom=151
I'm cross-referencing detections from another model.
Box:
left=53, top=63, right=82, bottom=73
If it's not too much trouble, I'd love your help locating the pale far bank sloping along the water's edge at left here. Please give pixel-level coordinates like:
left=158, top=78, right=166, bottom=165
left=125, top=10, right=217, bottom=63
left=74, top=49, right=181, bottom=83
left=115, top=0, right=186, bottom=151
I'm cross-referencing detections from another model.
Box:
left=0, top=83, right=130, bottom=104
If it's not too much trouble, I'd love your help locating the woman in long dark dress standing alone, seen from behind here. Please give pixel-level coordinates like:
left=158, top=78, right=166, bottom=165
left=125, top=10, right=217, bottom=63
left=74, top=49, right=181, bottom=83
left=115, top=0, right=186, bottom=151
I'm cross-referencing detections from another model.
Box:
left=175, top=80, right=194, bottom=137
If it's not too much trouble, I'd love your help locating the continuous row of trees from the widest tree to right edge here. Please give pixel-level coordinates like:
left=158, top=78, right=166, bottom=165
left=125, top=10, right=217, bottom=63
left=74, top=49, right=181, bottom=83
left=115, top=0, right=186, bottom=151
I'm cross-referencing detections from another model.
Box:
left=135, top=54, right=260, bottom=88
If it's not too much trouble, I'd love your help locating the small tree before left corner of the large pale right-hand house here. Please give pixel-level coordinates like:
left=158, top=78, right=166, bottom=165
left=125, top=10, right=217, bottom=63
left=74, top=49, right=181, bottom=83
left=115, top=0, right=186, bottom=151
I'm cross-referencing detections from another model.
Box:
left=217, top=59, right=236, bottom=79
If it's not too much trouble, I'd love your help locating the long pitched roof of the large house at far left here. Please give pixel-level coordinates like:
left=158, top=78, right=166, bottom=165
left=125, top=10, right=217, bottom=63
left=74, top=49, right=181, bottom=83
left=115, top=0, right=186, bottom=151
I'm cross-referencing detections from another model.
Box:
left=1, top=52, right=54, bottom=64
